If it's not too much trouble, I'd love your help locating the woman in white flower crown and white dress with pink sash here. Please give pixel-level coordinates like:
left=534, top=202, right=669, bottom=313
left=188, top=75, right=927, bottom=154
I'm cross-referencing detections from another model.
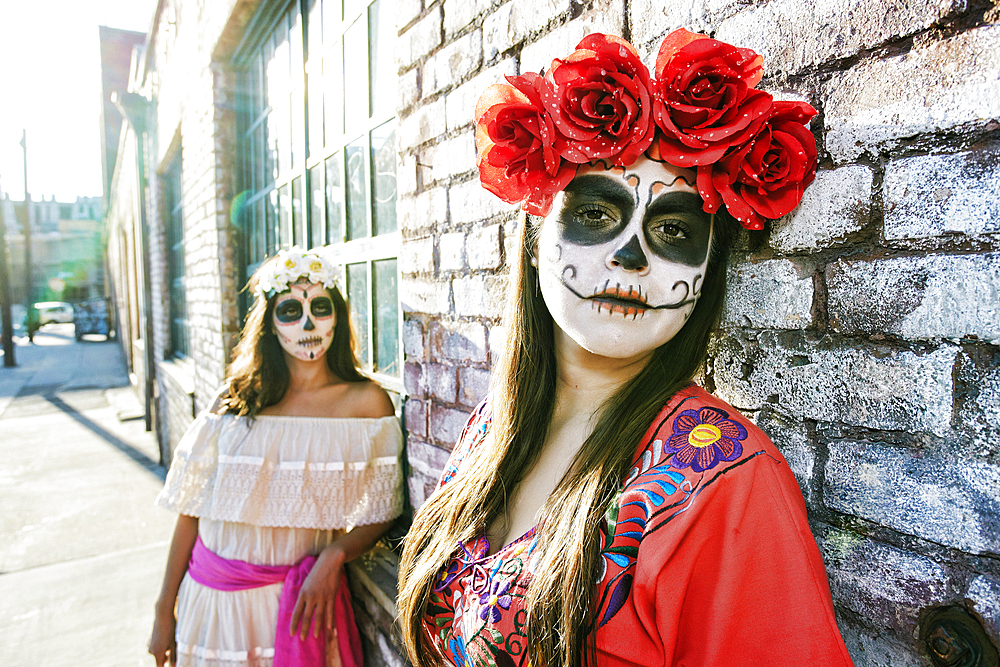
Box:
left=149, top=248, right=402, bottom=667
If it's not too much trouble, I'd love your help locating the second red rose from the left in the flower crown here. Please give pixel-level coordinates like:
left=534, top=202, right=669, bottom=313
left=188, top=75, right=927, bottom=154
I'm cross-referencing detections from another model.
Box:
left=542, top=33, right=656, bottom=166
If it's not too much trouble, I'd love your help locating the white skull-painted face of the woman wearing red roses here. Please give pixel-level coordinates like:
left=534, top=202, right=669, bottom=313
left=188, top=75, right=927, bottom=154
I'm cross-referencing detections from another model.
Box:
left=537, top=157, right=713, bottom=359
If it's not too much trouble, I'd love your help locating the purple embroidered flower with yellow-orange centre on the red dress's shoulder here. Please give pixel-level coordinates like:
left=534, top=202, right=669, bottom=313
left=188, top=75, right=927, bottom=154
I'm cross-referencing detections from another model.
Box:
left=663, top=407, right=747, bottom=472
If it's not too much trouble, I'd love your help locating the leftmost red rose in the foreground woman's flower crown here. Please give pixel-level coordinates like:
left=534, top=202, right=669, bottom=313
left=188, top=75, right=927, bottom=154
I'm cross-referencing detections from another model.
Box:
left=475, top=72, right=576, bottom=216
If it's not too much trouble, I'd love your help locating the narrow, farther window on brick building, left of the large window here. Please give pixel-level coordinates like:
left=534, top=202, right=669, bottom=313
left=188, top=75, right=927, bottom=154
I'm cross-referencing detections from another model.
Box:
left=163, top=149, right=191, bottom=356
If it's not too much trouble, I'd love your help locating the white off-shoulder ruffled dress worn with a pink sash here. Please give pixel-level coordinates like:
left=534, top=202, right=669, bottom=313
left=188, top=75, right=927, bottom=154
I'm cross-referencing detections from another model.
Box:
left=156, top=412, right=403, bottom=667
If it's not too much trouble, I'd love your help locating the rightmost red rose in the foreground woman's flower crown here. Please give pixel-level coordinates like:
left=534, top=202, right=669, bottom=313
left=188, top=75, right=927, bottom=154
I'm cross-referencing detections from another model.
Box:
left=698, top=102, right=816, bottom=229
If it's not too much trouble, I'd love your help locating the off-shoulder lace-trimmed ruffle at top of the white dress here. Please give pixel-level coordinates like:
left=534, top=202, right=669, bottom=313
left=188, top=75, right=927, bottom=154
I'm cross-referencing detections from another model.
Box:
left=157, top=414, right=403, bottom=530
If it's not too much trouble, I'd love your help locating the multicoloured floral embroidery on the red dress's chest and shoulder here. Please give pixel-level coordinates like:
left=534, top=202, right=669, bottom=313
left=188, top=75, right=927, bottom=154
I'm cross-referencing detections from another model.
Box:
left=427, top=395, right=762, bottom=667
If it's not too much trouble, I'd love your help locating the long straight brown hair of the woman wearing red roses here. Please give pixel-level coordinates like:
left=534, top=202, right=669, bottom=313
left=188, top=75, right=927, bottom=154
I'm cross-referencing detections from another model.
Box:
left=397, top=214, right=735, bottom=667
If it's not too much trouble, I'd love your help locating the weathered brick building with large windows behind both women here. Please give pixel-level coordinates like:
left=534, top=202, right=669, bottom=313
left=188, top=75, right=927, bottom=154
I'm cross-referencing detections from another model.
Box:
left=101, top=0, right=1000, bottom=666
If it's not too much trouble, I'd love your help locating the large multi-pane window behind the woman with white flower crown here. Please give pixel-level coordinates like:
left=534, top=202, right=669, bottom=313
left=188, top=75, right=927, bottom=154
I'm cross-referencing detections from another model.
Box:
left=236, top=0, right=402, bottom=390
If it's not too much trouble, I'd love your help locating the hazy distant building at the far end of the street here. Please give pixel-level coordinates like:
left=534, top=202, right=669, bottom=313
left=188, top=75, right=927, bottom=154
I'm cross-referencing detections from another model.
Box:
left=2, top=195, right=105, bottom=303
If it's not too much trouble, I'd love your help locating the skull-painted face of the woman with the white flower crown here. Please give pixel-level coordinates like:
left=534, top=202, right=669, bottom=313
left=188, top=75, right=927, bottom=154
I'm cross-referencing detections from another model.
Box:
left=272, top=281, right=337, bottom=361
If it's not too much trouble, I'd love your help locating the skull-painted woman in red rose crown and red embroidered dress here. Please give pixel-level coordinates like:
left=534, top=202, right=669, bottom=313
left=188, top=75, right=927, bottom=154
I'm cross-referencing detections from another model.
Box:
left=398, top=30, right=851, bottom=667
